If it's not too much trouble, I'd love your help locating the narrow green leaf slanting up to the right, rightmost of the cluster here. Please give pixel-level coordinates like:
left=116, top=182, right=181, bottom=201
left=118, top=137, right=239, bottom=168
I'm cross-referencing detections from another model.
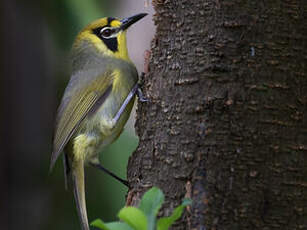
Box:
left=157, top=199, right=192, bottom=230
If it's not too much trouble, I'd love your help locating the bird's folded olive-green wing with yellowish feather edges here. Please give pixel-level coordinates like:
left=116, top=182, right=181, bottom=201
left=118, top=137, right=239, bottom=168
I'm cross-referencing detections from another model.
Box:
left=50, top=72, right=114, bottom=170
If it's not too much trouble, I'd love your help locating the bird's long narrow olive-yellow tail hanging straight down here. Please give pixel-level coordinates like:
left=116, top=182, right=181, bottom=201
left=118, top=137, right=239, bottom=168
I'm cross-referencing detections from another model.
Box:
left=72, top=160, right=90, bottom=230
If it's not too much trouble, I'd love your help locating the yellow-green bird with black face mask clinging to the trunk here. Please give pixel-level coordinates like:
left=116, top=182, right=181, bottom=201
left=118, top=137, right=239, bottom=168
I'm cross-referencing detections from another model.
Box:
left=50, top=13, right=147, bottom=230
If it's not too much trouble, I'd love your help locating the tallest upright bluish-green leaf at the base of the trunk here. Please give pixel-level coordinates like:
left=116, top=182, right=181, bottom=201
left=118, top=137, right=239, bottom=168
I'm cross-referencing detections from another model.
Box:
left=139, top=187, right=164, bottom=230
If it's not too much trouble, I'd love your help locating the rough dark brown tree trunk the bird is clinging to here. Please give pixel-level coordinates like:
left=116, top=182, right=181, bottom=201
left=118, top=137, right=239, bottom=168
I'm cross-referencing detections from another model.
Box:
left=128, top=0, right=307, bottom=230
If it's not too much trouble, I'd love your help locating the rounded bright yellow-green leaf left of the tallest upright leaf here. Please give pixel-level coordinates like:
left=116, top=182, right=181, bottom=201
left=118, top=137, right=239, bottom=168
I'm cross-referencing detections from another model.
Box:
left=118, top=207, right=147, bottom=230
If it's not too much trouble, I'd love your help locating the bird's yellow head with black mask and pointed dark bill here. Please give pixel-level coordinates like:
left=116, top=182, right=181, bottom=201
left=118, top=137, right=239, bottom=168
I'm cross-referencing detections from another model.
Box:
left=74, top=13, right=147, bottom=60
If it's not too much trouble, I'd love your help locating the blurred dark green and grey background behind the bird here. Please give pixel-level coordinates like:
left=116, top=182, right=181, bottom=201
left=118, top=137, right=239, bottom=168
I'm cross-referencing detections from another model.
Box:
left=0, top=0, right=154, bottom=230
